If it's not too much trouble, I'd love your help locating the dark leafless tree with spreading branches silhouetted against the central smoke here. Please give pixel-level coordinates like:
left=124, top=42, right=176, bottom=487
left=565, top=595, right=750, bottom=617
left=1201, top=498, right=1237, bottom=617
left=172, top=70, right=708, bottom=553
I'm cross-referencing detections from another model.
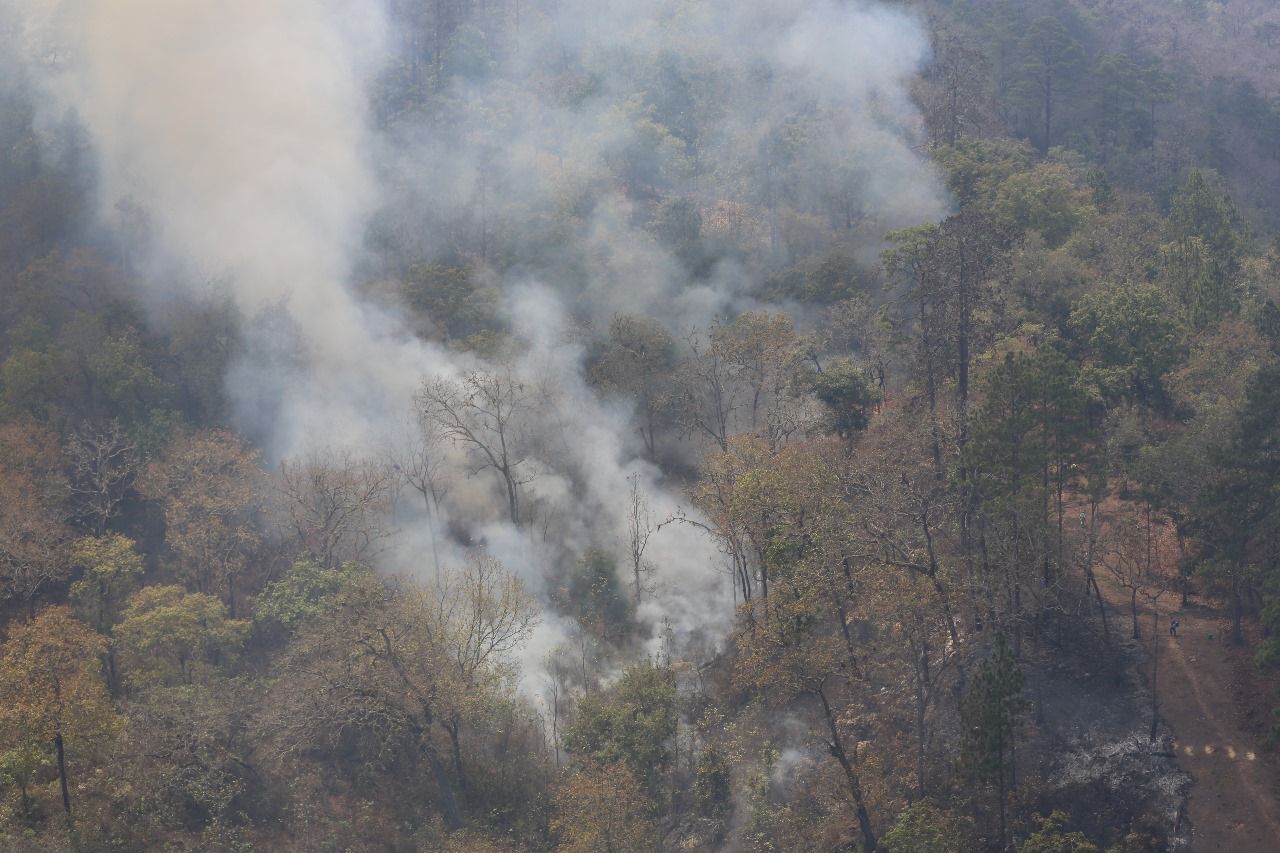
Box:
left=417, top=369, right=532, bottom=525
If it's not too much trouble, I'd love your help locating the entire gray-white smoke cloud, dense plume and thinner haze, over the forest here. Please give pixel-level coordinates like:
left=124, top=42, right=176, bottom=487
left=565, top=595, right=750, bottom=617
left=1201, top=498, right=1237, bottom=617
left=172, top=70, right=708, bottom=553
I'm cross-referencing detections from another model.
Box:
left=0, top=0, right=945, bottom=686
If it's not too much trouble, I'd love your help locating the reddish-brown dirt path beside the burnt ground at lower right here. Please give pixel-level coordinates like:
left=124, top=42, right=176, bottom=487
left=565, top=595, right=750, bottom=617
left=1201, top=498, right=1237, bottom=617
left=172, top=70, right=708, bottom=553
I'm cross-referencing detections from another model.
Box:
left=1131, top=596, right=1280, bottom=853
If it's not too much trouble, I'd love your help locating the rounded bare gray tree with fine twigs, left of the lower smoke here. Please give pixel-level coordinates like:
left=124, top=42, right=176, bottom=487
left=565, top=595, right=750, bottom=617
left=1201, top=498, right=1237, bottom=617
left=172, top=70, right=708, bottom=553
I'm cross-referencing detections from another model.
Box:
left=276, top=451, right=394, bottom=566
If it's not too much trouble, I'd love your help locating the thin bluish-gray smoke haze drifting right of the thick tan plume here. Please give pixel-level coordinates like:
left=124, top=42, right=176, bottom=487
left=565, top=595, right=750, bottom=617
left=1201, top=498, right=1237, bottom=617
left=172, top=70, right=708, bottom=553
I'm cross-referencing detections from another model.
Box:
left=379, top=0, right=946, bottom=327
